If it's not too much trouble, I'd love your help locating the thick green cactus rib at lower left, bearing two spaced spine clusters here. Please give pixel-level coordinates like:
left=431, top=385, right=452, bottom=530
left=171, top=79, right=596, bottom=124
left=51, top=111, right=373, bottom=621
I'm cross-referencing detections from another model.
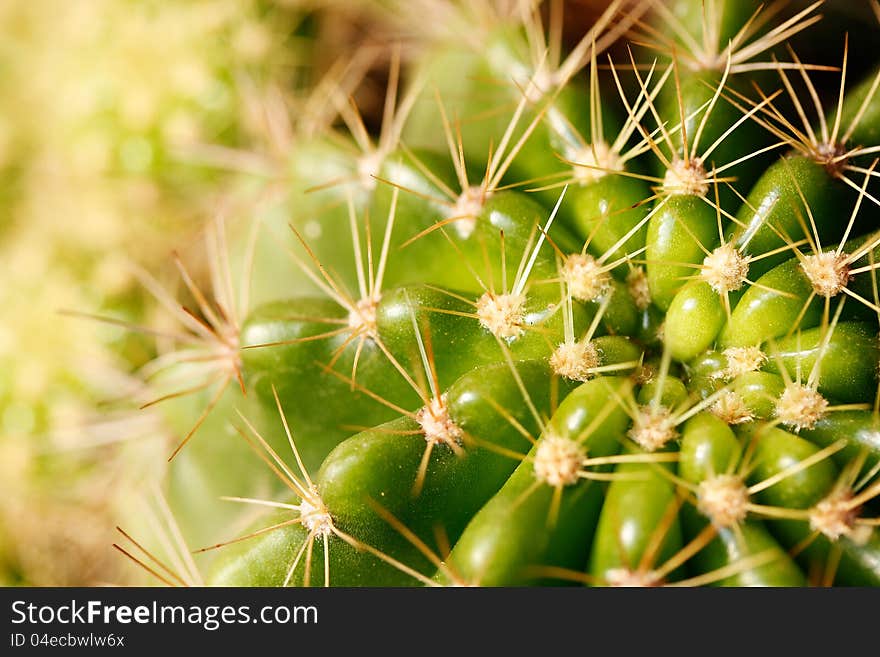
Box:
left=206, top=361, right=570, bottom=586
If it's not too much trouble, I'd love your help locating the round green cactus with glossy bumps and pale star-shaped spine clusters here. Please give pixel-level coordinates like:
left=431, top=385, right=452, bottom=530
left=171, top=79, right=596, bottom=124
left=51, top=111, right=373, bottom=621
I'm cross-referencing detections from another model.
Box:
left=22, top=0, right=880, bottom=586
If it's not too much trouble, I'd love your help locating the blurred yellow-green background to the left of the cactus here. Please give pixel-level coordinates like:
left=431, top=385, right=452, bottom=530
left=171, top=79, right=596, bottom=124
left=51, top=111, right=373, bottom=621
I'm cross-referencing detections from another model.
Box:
left=0, top=0, right=398, bottom=586
